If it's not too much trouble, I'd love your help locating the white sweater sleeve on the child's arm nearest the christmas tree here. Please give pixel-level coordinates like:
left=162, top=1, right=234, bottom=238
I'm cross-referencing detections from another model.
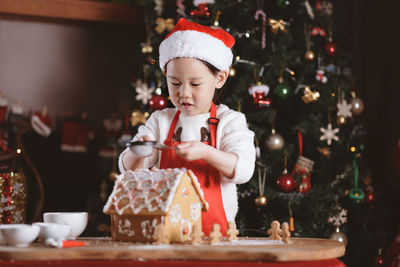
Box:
left=218, top=110, right=256, bottom=184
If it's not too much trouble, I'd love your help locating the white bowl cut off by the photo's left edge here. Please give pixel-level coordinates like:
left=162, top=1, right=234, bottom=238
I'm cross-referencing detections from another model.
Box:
left=0, top=224, right=40, bottom=248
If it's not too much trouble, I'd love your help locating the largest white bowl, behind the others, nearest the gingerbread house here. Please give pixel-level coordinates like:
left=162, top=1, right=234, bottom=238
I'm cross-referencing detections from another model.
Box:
left=43, top=212, right=88, bottom=239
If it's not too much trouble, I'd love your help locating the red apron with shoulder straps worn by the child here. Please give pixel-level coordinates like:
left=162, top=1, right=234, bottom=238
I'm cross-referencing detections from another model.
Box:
left=160, top=103, right=228, bottom=236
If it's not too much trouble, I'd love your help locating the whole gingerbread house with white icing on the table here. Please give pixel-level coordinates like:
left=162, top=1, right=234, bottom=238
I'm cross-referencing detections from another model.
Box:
left=103, top=169, right=208, bottom=242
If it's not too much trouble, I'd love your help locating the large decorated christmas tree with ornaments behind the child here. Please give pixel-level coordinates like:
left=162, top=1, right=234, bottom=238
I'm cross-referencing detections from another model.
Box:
left=126, top=0, right=375, bottom=266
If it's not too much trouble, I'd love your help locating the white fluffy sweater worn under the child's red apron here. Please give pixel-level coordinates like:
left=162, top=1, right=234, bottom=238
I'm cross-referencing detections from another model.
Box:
left=119, top=104, right=255, bottom=221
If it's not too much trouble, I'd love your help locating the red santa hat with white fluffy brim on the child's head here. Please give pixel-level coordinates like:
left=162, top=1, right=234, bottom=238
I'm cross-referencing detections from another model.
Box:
left=159, top=18, right=235, bottom=71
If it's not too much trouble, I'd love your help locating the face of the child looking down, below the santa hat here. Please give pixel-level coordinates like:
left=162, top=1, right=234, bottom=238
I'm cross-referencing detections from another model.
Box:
left=165, top=58, right=228, bottom=116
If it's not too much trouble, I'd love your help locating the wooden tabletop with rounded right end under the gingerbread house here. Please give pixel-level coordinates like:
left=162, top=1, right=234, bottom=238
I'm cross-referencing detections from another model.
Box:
left=0, top=238, right=345, bottom=265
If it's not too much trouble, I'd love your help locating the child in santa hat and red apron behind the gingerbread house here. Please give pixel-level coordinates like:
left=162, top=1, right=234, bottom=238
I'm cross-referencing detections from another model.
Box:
left=119, top=18, right=255, bottom=235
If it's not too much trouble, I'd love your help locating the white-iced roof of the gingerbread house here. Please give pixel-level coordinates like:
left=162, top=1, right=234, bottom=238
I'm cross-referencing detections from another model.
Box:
left=103, top=168, right=208, bottom=218
